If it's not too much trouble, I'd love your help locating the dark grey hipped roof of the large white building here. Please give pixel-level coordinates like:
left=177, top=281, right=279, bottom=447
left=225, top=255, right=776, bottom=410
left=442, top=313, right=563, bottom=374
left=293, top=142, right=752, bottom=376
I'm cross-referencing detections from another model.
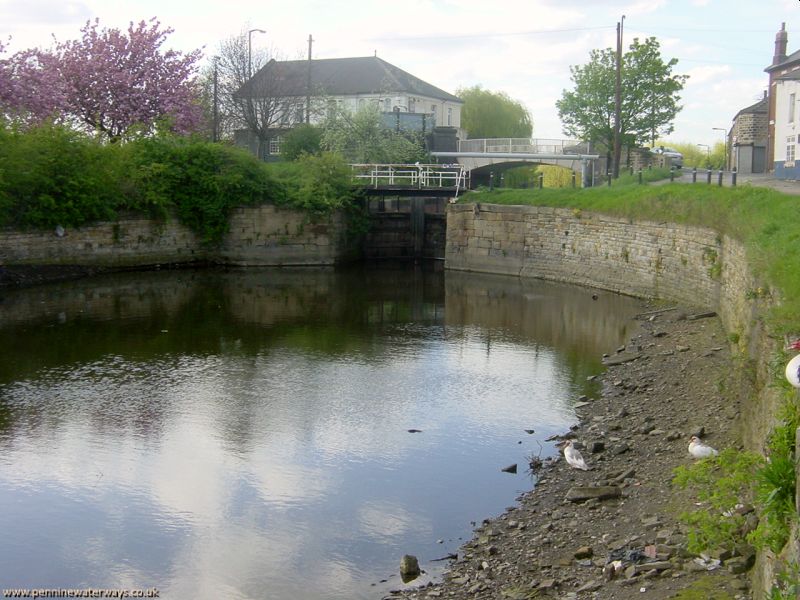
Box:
left=237, top=56, right=463, bottom=103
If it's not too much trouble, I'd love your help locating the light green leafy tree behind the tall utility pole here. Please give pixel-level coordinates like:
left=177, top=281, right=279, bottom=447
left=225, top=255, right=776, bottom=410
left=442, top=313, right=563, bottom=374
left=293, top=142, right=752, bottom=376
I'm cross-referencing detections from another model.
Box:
left=556, top=37, right=688, bottom=168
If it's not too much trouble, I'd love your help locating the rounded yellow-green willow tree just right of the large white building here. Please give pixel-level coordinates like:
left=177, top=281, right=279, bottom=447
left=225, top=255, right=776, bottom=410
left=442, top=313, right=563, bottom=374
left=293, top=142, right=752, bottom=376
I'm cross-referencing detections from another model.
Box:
left=456, top=85, right=533, bottom=138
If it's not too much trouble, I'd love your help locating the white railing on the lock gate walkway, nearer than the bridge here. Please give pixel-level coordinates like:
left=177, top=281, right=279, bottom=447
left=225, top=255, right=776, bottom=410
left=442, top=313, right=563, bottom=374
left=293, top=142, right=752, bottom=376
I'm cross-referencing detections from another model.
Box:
left=350, top=163, right=468, bottom=190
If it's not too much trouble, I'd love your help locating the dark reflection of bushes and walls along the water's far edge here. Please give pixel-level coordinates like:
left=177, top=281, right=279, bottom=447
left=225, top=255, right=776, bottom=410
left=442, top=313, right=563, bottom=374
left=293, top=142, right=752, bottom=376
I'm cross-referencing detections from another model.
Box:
left=0, top=265, right=637, bottom=446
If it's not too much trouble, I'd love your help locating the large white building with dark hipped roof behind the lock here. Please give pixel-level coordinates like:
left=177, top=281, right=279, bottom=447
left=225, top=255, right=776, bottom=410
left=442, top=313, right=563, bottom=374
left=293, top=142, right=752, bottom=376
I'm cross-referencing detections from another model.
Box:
left=236, top=56, right=464, bottom=154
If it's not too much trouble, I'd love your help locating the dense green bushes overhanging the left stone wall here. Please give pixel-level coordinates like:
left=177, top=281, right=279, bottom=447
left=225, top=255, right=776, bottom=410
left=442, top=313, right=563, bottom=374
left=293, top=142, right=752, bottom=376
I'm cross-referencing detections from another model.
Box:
left=0, top=124, right=360, bottom=244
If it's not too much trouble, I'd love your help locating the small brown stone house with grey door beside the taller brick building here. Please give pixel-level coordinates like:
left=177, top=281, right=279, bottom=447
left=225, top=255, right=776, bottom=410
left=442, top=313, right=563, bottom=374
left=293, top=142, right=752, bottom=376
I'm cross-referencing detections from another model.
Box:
left=728, top=91, right=769, bottom=174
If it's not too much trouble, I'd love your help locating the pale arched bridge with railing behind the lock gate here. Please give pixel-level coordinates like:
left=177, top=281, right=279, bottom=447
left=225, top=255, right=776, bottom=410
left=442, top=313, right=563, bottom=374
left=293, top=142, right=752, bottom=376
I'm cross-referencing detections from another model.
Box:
left=431, top=138, right=600, bottom=182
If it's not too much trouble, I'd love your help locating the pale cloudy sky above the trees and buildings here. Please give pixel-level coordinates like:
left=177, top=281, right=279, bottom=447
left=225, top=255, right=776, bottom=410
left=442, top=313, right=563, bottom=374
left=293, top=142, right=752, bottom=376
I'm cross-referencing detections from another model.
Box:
left=0, top=0, right=800, bottom=144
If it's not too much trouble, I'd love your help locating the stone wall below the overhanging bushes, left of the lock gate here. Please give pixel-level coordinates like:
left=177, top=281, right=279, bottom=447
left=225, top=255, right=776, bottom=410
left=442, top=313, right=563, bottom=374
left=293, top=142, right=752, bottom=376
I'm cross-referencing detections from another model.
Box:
left=0, top=205, right=348, bottom=268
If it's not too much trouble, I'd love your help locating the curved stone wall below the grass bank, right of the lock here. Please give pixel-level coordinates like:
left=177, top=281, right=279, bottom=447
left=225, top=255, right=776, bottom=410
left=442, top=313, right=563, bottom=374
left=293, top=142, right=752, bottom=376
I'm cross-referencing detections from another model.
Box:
left=445, top=204, right=800, bottom=598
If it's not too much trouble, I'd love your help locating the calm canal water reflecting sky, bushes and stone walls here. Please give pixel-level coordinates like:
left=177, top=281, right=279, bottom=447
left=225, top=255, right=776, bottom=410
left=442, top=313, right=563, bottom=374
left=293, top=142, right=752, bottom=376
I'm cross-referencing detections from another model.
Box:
left=0, top=265, right=640, bottom=600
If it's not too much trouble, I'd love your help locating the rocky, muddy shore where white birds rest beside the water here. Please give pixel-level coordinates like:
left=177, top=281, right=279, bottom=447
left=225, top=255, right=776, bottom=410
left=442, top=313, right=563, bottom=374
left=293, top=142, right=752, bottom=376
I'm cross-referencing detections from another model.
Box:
left=388, top=307, right=753, bottom=600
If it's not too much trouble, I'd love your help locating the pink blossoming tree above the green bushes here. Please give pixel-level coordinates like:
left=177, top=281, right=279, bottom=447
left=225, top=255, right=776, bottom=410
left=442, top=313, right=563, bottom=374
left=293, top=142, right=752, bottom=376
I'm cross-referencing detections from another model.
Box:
left=4, top=19, right=201, bottom=141
